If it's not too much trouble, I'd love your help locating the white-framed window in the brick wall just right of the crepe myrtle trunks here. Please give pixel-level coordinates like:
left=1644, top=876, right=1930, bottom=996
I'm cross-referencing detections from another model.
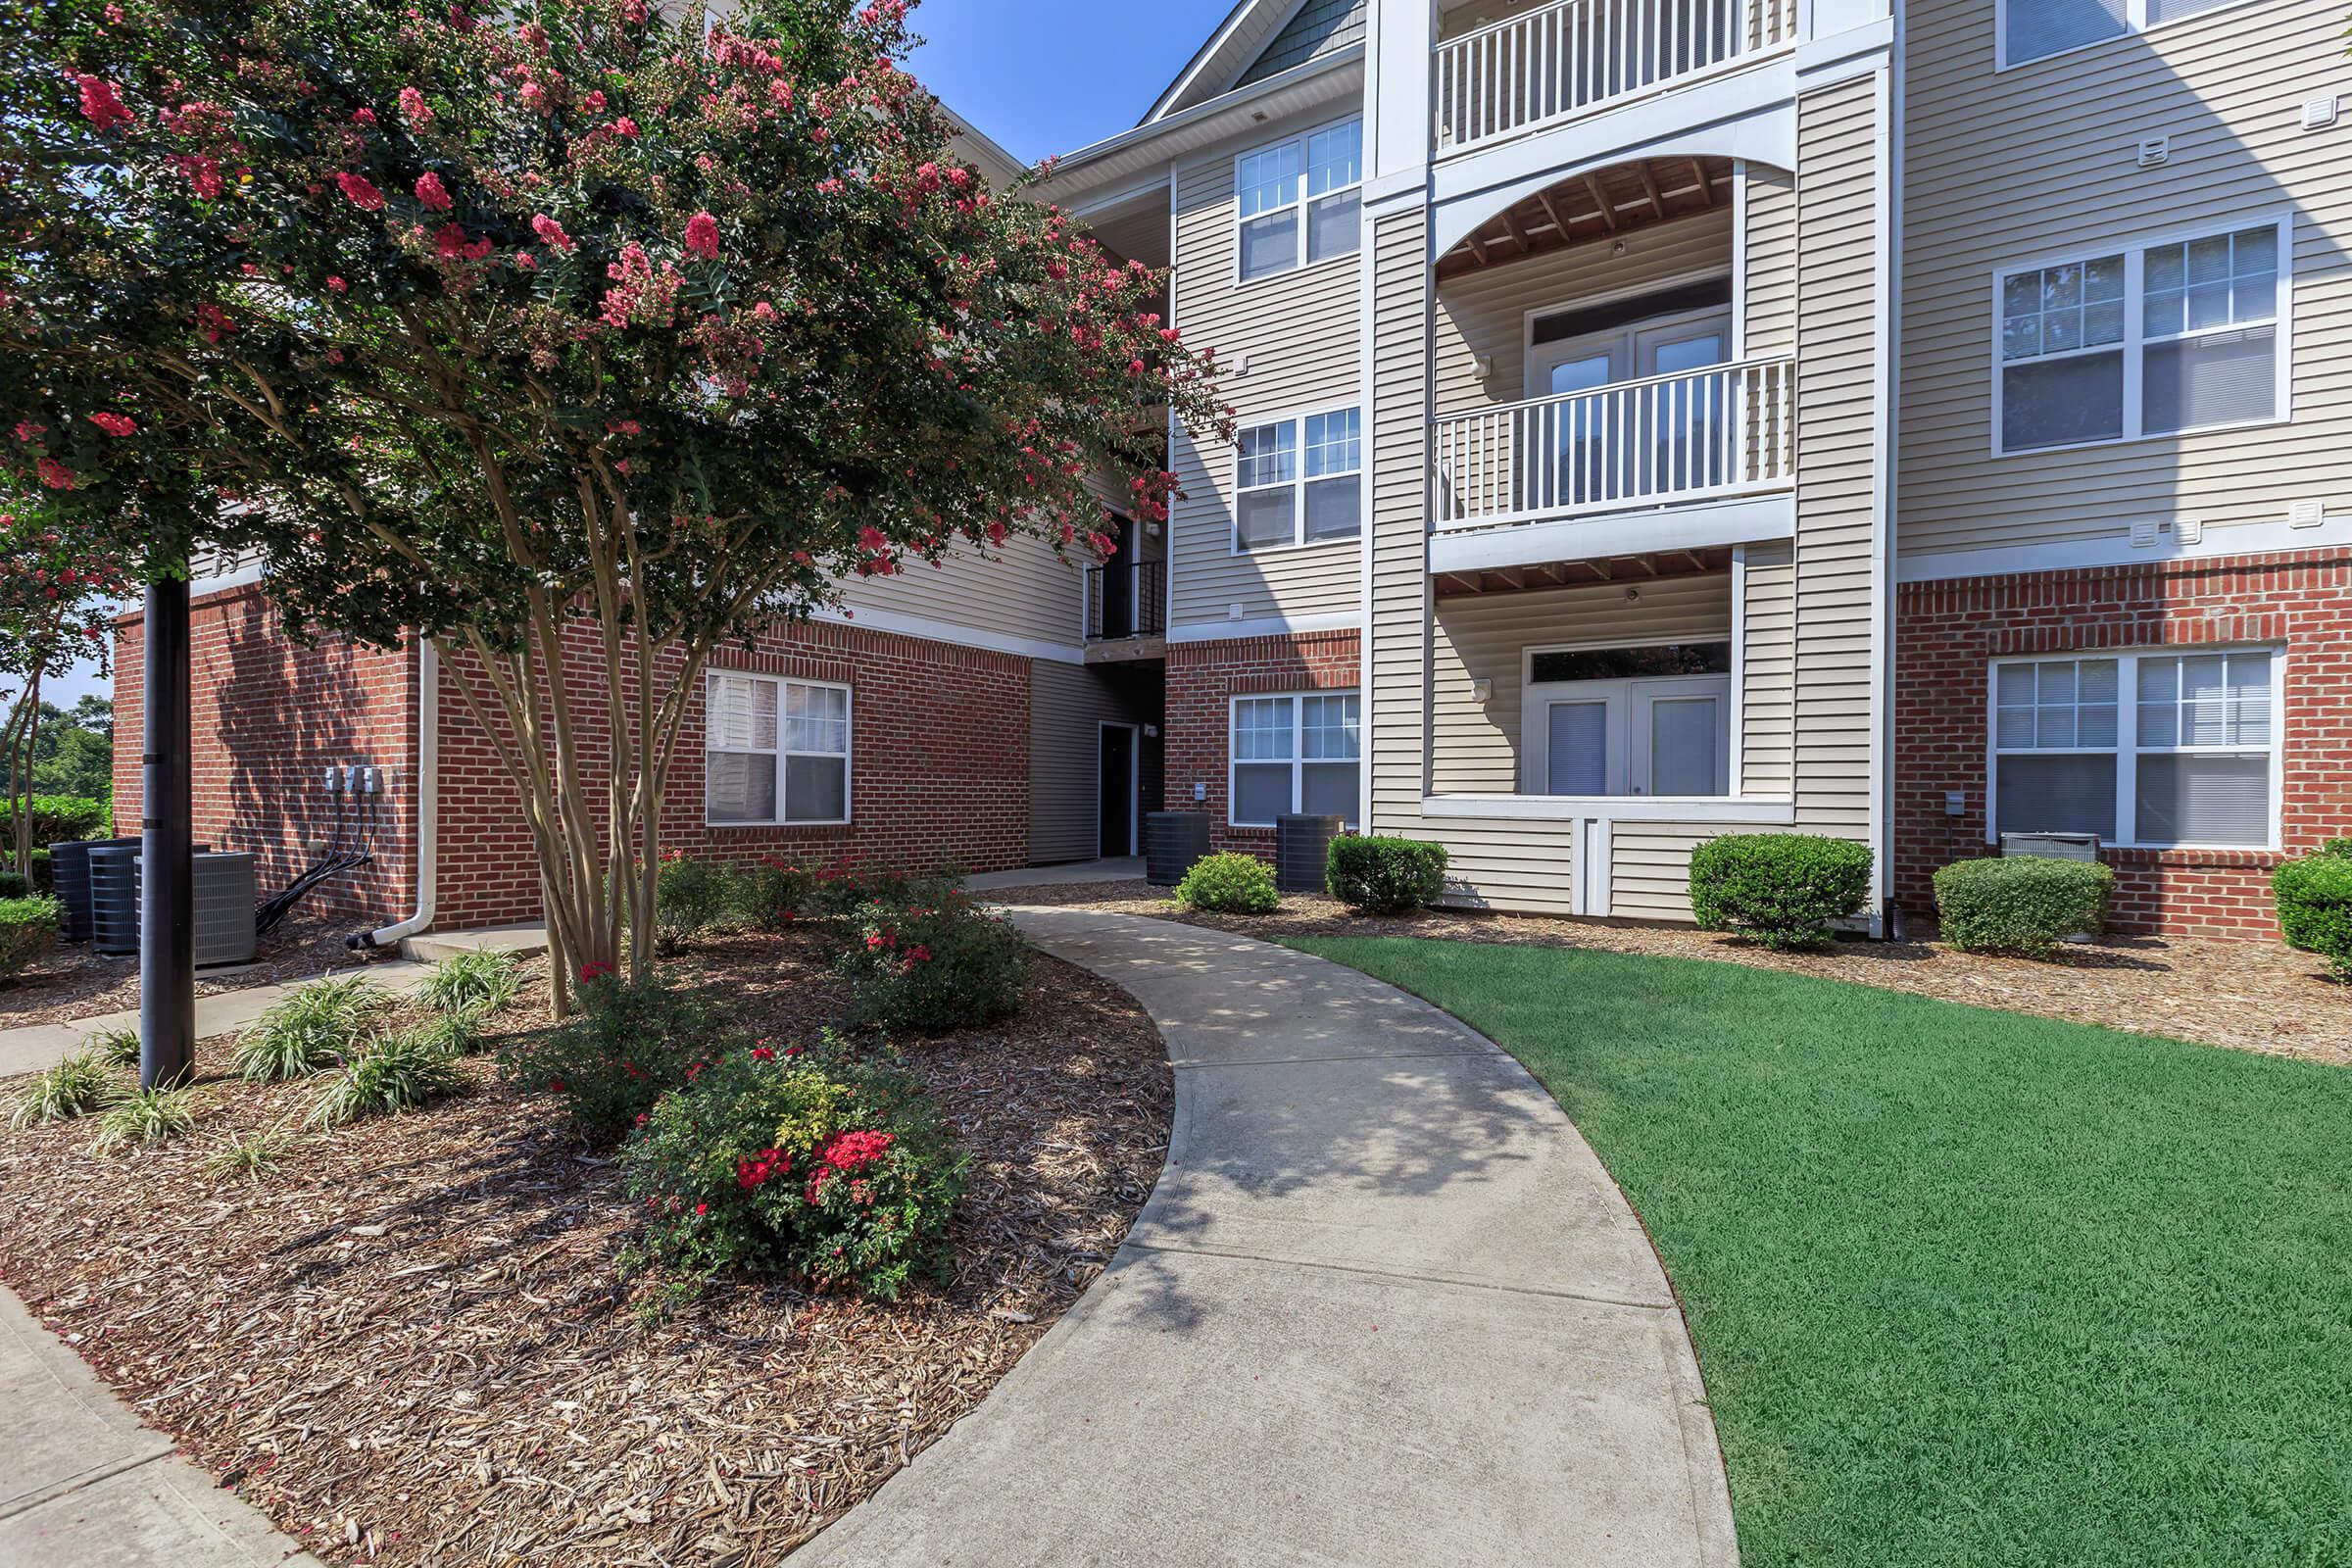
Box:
left=704, top=670, right=849, bottom=825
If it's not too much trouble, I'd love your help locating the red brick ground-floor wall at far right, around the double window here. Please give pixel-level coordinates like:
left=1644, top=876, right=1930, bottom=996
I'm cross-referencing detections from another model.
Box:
left=1893, top=550, right=2352, bottom=938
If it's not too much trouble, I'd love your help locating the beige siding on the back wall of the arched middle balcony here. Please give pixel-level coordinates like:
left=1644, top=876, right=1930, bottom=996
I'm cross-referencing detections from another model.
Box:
left=1435, top=207, right=1731, bottom=416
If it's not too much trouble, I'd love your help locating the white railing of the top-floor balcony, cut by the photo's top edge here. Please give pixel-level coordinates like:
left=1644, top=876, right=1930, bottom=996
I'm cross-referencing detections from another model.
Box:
left=1435, top=0, right=1797, bottom=153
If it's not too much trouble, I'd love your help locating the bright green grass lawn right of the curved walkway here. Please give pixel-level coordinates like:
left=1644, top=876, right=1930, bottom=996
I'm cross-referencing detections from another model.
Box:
left=1294, top=938, right=2352, bottom=1568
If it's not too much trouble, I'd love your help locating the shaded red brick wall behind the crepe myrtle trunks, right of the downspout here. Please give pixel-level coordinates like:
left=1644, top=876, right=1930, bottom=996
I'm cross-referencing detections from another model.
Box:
left=437, top=623, right=1030, bottom=929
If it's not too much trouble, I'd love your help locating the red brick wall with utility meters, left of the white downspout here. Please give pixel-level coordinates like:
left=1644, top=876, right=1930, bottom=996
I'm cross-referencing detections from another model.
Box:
left=116, top=588, right=416, bottom=929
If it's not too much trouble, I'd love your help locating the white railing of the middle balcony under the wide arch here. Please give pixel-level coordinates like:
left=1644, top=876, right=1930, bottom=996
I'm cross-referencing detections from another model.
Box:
left=1433, top=360, right=1797, bottom=529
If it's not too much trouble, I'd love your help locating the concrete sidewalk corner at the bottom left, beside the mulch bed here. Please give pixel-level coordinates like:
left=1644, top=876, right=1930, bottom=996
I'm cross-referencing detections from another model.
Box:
left=0, top=1291, right=319, bottom=1568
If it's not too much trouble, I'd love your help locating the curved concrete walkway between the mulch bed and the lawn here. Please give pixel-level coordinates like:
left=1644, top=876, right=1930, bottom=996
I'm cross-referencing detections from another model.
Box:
left=795, top=909, right=1739, bottom=1568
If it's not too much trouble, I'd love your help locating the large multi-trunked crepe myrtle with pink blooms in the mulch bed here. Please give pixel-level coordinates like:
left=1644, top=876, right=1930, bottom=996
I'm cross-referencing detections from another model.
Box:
left=14, top=0, right=1230, bottom=1005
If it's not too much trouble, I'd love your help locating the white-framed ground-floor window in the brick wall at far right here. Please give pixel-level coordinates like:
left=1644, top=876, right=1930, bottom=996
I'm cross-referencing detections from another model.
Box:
left=1989, top=649, right=2281, bottom=849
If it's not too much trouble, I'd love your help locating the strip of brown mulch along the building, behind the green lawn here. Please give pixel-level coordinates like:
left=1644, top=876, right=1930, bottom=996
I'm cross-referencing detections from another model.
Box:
left=988, top=882, right=2352, bottom=1065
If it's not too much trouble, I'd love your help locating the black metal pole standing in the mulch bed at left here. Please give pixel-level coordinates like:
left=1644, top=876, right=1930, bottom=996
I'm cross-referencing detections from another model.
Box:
left=139, top=578, right=195, bottom=1089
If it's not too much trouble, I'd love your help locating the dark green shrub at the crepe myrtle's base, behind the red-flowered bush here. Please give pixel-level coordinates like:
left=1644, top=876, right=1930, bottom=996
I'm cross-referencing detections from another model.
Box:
left=499, top=976, right=743, bottom=1145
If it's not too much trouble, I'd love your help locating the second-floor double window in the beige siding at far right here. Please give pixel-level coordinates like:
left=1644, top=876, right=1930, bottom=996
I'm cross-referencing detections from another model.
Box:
left=1992, top=220, right=2288, bottom=454
